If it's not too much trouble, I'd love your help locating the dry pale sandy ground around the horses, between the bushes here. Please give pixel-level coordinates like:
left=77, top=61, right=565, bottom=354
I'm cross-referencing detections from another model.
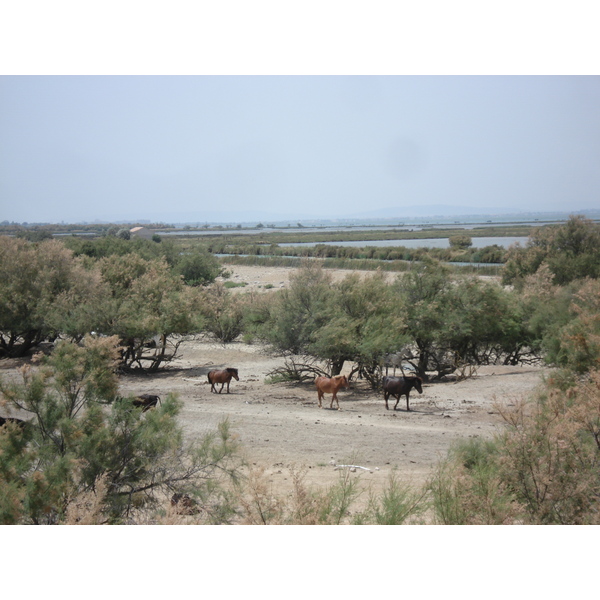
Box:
left=121, top=266, right=544, bottom=502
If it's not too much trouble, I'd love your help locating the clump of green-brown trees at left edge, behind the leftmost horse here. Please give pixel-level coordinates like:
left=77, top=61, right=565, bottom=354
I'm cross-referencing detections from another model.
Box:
left=0, top=236, right=211, bottom=371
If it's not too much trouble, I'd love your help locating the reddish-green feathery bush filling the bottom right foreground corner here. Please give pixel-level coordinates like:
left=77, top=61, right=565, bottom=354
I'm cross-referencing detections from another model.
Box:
left=429, top=370, right=600, bottom=525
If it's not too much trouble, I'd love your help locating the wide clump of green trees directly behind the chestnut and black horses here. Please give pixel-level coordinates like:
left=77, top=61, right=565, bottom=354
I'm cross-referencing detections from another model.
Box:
left=254, top=260, right=539, bottom=388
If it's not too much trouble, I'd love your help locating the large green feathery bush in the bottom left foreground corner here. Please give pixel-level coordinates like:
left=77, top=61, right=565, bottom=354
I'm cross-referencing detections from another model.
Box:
left=0, top=338, right=244, bottom=524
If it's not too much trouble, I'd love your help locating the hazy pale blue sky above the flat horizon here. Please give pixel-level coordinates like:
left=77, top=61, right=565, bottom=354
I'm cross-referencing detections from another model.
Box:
left=0, top=76, right=600, bottom=222
